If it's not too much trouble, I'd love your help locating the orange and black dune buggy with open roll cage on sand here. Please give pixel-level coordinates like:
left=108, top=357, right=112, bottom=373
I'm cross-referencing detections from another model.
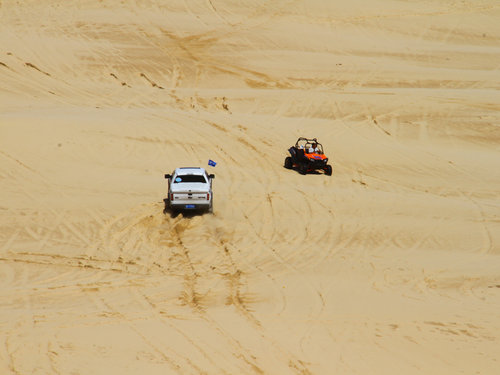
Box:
left=285, top=137, right=332, bottom=176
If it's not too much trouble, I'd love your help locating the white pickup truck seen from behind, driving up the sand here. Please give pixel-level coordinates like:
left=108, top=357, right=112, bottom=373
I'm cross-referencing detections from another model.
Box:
left=165, top=167, right=215, bottom=212
